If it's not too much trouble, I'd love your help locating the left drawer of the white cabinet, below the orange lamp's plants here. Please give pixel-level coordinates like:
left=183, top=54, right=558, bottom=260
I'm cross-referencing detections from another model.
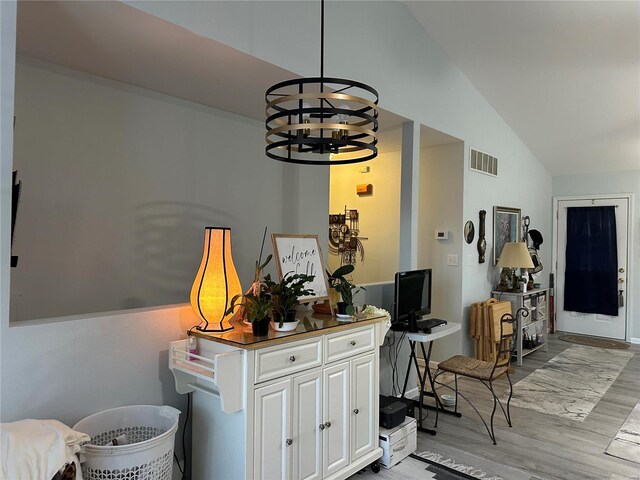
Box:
left=256, top=338, right=322, bottom=383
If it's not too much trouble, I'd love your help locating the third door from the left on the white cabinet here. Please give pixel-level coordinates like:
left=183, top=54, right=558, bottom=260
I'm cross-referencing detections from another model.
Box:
left=322, top=362, right=350, bottom=477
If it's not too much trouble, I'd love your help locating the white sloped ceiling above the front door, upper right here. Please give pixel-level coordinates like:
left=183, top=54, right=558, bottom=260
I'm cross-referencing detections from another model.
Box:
left=404, top=1, right=640, bottom=175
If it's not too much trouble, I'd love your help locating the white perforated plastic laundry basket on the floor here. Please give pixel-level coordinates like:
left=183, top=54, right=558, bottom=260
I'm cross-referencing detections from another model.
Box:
left=73, top=405, right=180, bottom=480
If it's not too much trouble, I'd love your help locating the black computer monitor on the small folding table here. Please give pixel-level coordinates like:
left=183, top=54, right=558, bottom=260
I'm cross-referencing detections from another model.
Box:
left=392, top=268, right=431, bottom=324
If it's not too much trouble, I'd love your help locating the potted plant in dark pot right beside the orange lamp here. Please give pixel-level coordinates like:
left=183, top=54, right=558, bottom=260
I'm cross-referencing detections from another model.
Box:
left=226, top=255, right=273, bottom=335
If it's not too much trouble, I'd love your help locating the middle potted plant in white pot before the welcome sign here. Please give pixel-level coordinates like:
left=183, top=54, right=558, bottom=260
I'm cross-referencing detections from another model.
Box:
left=264, top=272, right=315, bottom=328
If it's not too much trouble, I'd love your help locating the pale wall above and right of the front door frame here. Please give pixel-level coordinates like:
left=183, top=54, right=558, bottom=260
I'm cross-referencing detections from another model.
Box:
left=549, top=169, right=640, bottom=343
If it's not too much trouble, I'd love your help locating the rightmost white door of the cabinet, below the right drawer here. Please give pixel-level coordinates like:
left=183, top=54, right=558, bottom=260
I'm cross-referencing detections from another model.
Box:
left=350, top=354, right=377, bottom=461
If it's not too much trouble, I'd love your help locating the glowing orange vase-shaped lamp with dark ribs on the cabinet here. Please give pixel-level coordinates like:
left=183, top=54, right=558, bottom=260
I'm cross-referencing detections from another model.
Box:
left=191, top=227, right=242, bottom=332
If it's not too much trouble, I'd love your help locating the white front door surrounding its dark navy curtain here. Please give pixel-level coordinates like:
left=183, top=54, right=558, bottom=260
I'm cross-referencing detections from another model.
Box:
left=555, top=198, right=629, bottom=340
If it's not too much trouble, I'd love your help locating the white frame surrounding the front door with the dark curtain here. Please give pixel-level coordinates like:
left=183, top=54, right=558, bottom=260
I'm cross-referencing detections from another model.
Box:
left=551, top=193, right=636, bottom=342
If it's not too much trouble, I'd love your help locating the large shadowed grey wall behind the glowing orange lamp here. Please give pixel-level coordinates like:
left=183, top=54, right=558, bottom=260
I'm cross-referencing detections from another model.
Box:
left=11, top=58, right=285, bottom=321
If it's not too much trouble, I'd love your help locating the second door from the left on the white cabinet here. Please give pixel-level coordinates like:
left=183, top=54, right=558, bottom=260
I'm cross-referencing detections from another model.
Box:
left=291, top=370, right=324, bottom=480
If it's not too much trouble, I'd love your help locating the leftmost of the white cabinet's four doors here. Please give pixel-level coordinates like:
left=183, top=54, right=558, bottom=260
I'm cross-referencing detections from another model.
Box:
left=253, top=380, right=291, bottom=480
